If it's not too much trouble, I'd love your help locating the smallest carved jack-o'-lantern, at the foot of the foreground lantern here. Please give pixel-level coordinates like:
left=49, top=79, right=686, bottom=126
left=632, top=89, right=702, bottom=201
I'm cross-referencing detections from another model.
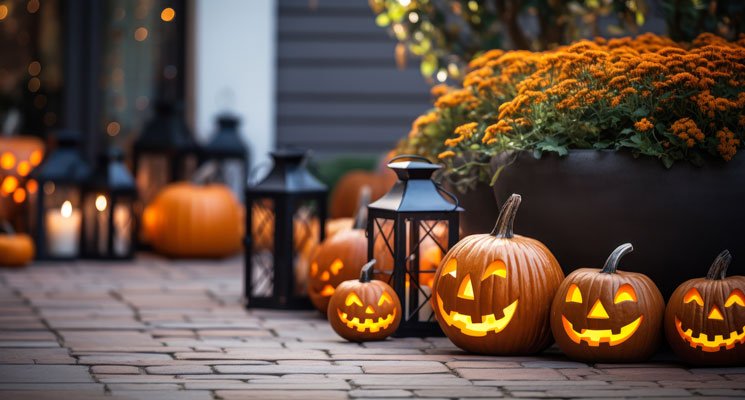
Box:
left=327, top=260, right=401, bottom=342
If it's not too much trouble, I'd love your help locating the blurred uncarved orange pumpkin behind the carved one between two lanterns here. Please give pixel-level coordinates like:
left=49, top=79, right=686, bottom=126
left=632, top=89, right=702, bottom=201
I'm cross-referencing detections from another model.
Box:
left=329, top=170, right=392, bottom=218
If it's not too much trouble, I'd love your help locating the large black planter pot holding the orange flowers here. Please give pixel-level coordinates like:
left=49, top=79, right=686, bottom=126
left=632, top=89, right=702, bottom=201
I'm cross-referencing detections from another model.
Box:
left=488, top=150, right=745, bottom=298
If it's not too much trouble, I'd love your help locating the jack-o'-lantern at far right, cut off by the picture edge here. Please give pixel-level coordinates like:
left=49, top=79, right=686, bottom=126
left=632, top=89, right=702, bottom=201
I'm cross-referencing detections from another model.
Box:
left=665, top=250, right=745, bottom=365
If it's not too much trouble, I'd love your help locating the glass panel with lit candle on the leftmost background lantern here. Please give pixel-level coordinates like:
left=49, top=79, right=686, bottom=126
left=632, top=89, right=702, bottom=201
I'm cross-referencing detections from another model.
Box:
left=41, top=182, right=82, bottom=258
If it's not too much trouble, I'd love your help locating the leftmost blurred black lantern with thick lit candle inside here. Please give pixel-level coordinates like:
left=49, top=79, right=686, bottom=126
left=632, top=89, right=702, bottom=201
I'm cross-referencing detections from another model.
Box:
left=29, top=131, right=91, bottom=260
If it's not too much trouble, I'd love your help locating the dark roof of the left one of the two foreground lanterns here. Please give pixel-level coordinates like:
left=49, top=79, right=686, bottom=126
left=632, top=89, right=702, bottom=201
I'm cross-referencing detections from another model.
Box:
left=246, top=148, right=328, bottom=194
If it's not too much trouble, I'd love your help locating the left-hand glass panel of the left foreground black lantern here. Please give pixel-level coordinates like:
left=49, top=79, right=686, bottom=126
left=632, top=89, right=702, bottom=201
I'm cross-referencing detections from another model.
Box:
left=247, top=198, right=275, bottom=297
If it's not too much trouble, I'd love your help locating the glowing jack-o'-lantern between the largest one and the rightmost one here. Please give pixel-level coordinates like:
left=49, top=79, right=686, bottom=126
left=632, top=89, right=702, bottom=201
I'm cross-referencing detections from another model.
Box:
left=551, top=243, right=665, bottom=362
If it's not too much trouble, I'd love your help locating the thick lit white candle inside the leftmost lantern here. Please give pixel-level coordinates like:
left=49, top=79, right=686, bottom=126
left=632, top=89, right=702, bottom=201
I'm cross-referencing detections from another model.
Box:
left=46, top=201, right=82, bottom=257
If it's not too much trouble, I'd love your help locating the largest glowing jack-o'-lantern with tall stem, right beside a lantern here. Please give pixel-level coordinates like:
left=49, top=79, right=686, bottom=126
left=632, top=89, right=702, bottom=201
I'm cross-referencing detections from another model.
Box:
left=432, top=194, right=564, bottom=354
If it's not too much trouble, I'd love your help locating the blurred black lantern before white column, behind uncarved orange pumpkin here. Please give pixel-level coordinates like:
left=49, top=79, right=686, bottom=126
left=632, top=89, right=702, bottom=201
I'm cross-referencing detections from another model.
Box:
left=199, top=114, right=248, bottom=200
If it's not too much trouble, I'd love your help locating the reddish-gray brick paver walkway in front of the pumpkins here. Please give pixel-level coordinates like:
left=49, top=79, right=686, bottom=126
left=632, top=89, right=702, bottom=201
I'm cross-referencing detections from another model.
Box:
left=0, top=258, right=745, bottom=400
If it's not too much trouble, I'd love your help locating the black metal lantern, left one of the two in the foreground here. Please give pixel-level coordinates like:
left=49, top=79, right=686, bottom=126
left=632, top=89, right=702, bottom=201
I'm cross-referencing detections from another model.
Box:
left=245, top=150, right=328, bottom=309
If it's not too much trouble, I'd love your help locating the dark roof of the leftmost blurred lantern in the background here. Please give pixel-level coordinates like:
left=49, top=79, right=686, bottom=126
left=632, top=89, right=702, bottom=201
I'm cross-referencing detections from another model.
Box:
left=30, top=130, right=91, bottom=184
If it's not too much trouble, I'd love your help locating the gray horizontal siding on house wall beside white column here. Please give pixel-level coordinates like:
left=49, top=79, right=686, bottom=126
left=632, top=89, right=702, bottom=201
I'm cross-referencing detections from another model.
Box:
left=277, top=0, right=431, bottom=158
